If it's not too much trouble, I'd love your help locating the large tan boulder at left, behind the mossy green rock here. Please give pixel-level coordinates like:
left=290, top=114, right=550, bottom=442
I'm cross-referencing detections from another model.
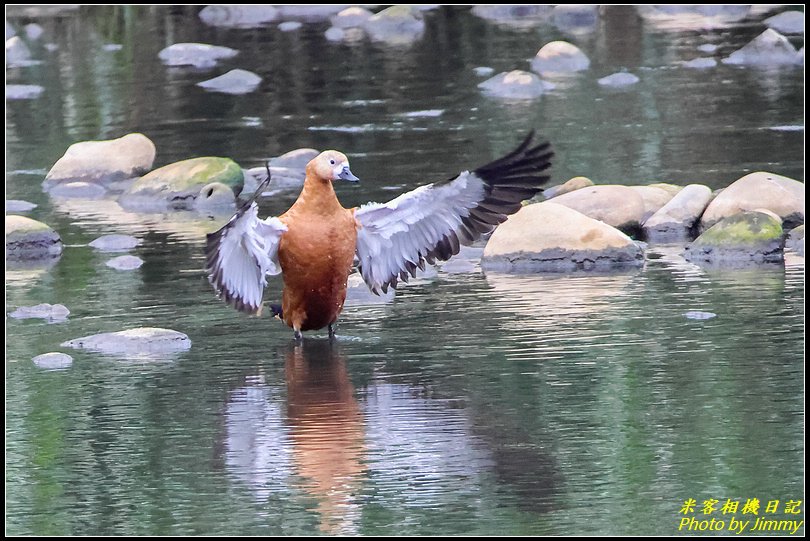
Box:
left=43, top=133, right=155, bottom=190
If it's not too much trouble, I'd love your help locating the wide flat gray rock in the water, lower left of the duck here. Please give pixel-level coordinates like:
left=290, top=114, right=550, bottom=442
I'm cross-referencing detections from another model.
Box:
left=60, top=327, right=191, bottom=355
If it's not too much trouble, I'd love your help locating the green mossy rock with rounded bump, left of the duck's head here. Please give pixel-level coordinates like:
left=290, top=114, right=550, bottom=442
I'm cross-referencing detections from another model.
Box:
left=118, top=157, right=244, bottom=210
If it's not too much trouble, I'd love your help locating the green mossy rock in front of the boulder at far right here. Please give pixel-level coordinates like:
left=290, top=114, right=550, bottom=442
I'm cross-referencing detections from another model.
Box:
left=685, top=211, right=784, bottom=265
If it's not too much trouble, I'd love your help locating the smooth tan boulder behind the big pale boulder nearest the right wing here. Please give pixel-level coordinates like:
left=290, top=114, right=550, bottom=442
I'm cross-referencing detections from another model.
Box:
left=554, top=184, right=645, bottom=233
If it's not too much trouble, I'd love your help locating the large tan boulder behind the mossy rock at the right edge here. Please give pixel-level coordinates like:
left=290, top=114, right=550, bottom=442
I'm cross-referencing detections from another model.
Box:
left=700, top=171, right=804, bottom=229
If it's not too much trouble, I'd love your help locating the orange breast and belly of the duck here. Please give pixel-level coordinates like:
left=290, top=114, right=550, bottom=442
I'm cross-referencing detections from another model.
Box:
left=278, top=207, right=357, bottom=331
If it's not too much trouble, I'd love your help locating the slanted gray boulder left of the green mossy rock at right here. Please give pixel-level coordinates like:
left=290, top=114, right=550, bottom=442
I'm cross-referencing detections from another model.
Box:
left=644, top=184, right=712, bottom=242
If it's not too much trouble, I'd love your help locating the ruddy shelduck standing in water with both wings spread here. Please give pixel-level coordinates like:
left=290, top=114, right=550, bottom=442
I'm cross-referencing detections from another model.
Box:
left=206, top=132, right=553, bottom=339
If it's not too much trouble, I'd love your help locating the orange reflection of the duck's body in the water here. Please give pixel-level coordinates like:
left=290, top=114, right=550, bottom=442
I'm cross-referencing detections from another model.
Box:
left=286, top=340, right=366, bottom=534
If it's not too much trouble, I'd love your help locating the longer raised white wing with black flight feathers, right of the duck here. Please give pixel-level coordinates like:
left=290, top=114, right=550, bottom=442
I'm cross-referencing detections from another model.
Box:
left=355, top=132, right=554, bottom=293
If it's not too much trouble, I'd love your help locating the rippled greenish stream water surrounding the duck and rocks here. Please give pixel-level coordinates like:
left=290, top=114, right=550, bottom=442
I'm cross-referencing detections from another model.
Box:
left=6, top=7, right=804, bottom=535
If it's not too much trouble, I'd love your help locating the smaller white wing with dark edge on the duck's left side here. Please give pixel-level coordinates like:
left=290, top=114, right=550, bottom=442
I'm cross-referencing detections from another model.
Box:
left=205, top=201, right=287, bottom=314
